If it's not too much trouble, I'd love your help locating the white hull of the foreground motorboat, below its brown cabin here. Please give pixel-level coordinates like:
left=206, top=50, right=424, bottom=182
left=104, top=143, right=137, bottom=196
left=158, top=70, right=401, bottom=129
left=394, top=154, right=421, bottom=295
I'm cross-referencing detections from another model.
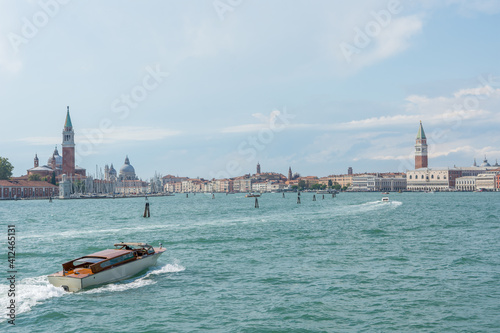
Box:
left=48, top=252, right=162, bottom=292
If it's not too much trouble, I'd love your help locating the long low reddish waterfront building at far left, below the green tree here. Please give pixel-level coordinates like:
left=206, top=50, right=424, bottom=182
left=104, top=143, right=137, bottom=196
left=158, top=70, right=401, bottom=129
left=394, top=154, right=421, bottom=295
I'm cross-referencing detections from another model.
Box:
left=0, top=180, right=59, bottom=199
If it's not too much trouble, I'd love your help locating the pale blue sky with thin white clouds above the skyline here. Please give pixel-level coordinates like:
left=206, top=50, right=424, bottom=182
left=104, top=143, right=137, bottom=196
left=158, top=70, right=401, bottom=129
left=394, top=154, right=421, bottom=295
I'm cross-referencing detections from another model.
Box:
left=0, top=0, right=500, bottom=179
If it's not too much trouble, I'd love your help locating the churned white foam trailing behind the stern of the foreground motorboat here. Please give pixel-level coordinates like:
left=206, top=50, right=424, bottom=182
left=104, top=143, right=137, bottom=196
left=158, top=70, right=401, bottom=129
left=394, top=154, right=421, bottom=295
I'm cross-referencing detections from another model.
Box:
left=0, top=275, right=66, bottom=322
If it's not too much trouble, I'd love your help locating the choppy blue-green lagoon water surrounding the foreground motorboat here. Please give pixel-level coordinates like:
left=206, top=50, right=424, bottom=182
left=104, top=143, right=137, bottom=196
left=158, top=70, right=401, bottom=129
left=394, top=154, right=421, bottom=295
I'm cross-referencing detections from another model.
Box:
left=0, top=193, right=500, bottom=332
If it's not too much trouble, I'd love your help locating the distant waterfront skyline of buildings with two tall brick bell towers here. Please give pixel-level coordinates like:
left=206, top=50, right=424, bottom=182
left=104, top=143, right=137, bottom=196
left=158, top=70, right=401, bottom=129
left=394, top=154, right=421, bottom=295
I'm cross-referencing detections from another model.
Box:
left=4, top=113, right=500, bottom=199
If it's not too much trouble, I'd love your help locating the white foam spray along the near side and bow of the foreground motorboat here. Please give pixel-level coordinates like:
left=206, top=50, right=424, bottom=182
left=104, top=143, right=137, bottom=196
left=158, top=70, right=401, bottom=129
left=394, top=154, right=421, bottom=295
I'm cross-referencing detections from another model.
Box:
left=78, top=263, right=186, bottom=295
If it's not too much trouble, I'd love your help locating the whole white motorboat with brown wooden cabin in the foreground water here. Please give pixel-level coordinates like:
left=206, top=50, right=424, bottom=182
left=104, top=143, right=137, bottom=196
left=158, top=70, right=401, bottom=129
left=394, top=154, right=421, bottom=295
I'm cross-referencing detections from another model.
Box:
left=48, top=243, right=166, bottom=292
